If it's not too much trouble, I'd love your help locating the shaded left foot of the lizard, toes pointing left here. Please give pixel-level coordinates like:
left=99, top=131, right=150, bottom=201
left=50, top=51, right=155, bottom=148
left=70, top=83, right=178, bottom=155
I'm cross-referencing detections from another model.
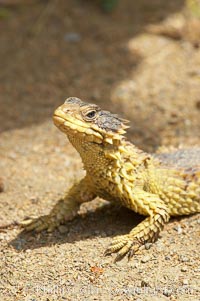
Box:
left=20, top=215, right=60, bottom=232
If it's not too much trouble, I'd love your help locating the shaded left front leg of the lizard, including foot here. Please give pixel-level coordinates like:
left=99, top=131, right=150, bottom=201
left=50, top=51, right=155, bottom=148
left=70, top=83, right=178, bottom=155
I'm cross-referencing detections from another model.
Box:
left=21, top=176, right=96, bottom=232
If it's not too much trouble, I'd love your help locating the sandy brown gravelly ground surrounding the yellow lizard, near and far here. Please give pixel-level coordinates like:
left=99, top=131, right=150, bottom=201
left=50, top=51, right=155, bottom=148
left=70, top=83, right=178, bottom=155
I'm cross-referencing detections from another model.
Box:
left=0, top=0, right=200, bottom=301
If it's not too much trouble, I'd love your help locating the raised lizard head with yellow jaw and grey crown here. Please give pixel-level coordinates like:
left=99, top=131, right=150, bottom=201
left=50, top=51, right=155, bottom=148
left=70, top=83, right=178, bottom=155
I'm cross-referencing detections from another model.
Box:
left=53, top=97, right=128, bottom=144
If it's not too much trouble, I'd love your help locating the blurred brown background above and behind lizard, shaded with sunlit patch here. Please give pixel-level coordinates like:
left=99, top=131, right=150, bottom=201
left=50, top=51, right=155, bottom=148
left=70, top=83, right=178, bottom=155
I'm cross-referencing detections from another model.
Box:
left=0, top=0, right=200, bottom=150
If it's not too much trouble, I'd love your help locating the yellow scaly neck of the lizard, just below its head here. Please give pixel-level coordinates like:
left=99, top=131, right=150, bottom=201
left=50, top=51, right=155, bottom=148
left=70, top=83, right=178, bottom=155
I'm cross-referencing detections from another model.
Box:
left=65, top=134, right=149, bottom=177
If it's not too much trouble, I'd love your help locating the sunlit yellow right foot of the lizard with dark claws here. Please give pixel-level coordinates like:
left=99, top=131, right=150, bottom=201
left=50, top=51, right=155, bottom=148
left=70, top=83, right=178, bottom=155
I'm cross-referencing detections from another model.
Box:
left=104, top=234, right=143, bottom=262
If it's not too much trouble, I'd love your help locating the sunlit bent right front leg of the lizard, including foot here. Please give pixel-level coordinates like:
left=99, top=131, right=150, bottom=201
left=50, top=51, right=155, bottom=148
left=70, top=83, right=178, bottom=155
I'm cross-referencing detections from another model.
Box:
left=105, top=189, right=170, bottom=261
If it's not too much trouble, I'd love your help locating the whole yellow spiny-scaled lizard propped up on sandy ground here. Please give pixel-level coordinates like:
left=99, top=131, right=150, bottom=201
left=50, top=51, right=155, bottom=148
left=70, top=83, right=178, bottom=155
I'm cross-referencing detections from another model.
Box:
left=23, top=97, right=200, bottom=260
